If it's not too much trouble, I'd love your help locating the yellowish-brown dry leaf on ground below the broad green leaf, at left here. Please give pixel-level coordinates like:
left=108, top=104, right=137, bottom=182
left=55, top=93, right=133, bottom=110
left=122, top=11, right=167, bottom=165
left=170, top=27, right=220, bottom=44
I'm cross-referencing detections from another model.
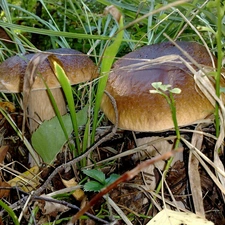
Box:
left=8, top=166, right=39, bottom=192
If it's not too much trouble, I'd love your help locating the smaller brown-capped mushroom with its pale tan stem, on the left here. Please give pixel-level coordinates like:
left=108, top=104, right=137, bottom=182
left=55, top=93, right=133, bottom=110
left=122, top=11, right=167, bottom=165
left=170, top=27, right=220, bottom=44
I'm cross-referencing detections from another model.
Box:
left=0, top=48, right=97, bottom=132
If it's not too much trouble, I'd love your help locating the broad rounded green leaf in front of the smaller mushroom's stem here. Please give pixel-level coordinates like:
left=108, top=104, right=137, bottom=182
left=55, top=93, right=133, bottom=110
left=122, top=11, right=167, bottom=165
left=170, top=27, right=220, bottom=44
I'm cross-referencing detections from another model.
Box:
left=31, top=106, right=88, bottom=164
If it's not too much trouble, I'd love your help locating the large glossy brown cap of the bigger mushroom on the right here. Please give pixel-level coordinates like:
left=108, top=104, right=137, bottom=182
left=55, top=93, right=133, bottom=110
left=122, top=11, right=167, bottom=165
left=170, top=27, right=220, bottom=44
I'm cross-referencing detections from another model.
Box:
left=101, top=42, right=223, bottom=132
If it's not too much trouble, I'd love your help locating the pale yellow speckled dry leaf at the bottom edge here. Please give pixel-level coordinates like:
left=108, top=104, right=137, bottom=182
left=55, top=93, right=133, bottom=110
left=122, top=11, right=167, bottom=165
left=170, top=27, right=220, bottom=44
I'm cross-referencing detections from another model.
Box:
left=147, top=209, right=214, bottom=225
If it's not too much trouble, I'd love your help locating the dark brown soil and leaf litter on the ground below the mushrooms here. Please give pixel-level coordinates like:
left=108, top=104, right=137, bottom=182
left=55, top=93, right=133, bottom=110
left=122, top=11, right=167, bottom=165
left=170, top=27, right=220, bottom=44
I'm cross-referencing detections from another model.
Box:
left=0, top=110, right=225, bottom=225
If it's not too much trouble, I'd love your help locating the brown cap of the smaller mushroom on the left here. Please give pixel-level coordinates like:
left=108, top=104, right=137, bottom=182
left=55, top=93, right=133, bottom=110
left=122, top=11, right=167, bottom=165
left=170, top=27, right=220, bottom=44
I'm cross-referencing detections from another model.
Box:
left=0, top=48, right=97, bottom=93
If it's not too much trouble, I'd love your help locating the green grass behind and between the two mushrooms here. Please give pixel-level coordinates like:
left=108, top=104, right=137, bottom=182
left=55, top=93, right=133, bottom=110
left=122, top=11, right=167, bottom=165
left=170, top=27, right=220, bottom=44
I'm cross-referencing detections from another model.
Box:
left=0, top=0, right=225, bottom=224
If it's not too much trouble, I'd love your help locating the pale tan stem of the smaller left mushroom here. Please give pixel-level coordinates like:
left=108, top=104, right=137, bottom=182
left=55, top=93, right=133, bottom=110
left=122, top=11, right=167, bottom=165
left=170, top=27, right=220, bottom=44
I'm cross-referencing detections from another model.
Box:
left=28, top=88, right=67, bottom=133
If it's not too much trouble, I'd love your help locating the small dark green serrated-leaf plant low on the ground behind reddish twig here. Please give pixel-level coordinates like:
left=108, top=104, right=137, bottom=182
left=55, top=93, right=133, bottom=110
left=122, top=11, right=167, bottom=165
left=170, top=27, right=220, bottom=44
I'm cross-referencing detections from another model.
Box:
left=83, top=169, right=120, bottom=192
